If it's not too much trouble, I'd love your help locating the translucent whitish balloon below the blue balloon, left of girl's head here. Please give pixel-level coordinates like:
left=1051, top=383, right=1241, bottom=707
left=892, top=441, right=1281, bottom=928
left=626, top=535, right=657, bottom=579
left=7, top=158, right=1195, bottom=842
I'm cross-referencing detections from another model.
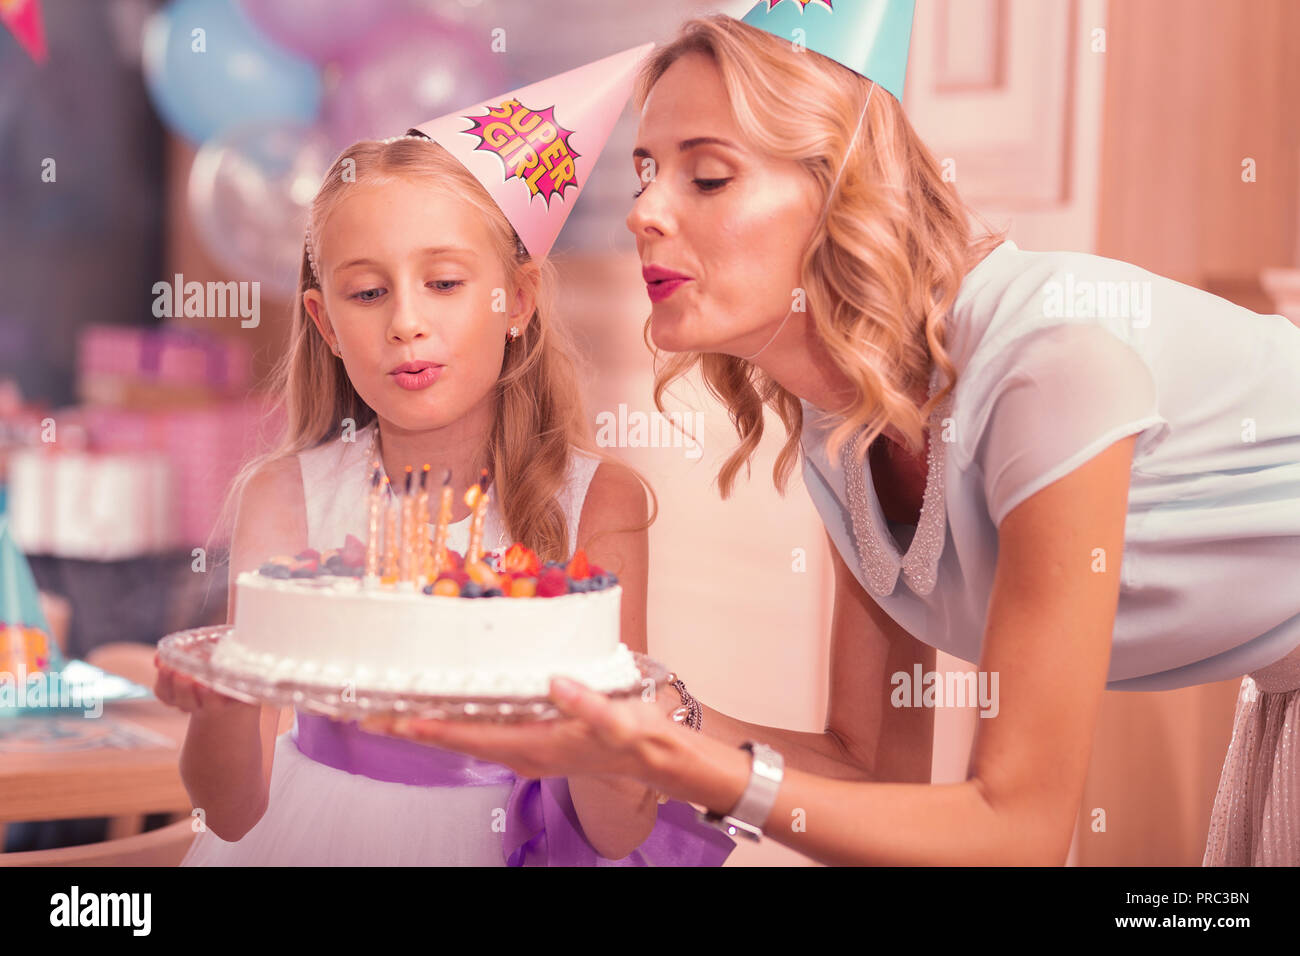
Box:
left=189, top=121, right=335, bottom=298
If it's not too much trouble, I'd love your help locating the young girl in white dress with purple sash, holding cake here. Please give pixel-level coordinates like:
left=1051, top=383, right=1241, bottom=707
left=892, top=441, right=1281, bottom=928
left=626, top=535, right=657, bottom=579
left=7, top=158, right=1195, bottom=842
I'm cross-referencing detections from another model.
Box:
left=157, top=54, right=732, bottom=865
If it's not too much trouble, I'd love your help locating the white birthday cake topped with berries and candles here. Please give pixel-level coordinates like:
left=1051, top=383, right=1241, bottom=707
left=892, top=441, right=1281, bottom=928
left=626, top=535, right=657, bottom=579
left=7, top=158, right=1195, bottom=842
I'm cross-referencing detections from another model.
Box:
left=212, top=470, right=641, bottom=698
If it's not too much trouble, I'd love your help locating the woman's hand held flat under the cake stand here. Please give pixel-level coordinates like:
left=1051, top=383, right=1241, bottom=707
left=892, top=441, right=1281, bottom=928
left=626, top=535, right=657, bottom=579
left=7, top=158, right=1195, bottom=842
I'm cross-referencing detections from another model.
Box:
left=360, top=678, right=681, bottom=784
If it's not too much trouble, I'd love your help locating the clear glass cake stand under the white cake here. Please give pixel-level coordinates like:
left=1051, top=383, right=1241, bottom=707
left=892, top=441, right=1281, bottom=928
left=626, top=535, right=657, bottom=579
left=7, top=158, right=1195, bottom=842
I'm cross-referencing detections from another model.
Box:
left=159, top=624, right=672, bottom=722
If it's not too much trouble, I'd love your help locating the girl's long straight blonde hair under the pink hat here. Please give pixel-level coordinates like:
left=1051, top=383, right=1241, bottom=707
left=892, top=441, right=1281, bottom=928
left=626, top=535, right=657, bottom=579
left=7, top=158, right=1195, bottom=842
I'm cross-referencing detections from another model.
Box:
left=228, top=137, right=658, bottom=561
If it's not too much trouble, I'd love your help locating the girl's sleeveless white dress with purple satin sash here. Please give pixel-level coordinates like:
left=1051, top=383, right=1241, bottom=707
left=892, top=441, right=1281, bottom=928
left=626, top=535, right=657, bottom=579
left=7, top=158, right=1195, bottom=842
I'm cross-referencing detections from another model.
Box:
left=181, top=425, right=735, bottom=866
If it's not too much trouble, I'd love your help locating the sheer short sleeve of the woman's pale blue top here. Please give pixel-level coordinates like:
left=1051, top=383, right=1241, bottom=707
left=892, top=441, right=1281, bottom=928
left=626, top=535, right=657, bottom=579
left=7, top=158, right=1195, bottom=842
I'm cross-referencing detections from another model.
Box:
left=976, top=325, right=1169, bottom=525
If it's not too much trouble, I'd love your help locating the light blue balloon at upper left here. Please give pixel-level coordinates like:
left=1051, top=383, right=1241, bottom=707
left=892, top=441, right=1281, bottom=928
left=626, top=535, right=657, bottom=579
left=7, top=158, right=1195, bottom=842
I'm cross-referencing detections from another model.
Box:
left=144, top=0, right=321, bottom=144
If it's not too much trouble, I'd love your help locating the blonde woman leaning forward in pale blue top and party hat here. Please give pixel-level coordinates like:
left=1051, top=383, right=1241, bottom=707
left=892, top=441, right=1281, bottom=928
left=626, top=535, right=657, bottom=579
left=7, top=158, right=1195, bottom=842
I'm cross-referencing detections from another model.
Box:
left=371, top=0, right=1300, bottom=865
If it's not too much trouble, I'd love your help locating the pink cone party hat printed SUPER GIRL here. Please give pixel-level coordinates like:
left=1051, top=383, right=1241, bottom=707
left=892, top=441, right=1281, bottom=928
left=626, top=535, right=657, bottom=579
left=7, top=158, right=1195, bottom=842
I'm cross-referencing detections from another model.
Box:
left=413, top=43, right=654, bottom=259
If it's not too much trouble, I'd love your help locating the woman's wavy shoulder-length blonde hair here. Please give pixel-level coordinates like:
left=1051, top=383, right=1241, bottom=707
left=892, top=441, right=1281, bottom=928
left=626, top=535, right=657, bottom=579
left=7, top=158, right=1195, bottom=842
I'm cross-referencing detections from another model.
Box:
left=637, top=14, right=1005, bottom=498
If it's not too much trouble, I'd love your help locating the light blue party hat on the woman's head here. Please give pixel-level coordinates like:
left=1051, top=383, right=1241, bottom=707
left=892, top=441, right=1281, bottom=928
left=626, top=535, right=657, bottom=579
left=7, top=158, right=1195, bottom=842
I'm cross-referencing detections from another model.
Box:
left=742, top=0, right=917, bottom=103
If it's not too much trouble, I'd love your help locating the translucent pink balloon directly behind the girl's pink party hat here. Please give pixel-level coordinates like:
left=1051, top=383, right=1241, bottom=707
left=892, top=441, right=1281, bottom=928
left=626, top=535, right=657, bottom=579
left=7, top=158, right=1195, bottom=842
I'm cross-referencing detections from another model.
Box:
left=325, top=17, right=507, bottom=148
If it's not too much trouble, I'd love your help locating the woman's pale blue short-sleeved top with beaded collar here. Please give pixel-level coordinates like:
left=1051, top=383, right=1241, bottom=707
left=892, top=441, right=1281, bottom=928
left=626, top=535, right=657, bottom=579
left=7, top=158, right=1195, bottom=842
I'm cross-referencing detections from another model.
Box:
left=802, top=242, right=1300, bottom=691
